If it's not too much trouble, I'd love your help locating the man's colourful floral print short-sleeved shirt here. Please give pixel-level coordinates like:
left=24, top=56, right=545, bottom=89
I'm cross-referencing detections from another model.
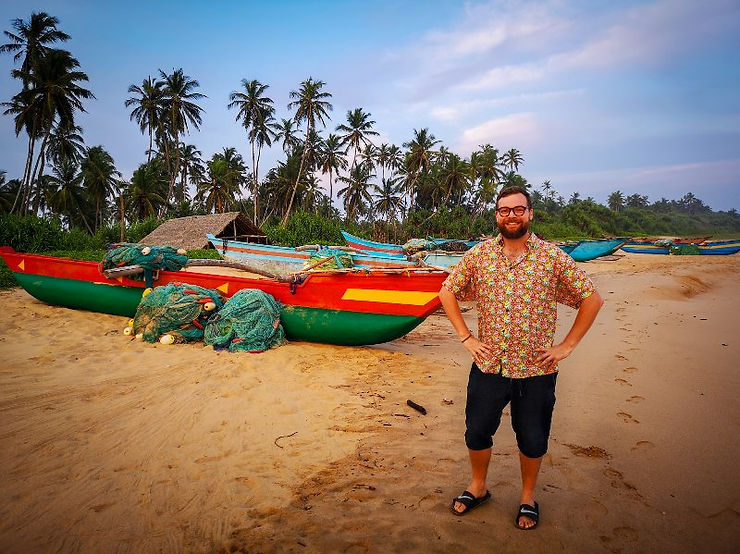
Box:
left=443, top=234, right=596, bottom=379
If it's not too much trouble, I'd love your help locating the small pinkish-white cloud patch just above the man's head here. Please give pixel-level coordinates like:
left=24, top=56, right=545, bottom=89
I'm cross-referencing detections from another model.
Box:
left=455, top=112, right=540, bottom=155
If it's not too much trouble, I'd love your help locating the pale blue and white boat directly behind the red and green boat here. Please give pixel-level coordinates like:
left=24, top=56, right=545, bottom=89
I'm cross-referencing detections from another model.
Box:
left=206, top=234, right=422, bottom=273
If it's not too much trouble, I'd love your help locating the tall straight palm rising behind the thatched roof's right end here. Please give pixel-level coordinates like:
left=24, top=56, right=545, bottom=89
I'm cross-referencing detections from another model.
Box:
left=228, top=79, right=275, bottom=221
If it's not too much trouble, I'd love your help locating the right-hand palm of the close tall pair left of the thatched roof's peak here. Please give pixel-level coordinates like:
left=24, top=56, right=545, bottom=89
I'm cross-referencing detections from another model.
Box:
left=159, top=68, right=206, bottom=202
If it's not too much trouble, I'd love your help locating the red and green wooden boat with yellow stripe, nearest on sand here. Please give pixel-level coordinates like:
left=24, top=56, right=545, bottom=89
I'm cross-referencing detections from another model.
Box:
left=0, top=247, right=447, bottom=345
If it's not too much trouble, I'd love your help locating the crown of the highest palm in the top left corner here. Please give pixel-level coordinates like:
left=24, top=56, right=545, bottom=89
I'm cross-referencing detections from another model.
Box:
left=0, top=12, right=69, bottom=84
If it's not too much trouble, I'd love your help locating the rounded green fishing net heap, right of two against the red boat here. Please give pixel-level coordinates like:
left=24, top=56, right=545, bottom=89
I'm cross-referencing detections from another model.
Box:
left=203, top=289, right=285, bottom=352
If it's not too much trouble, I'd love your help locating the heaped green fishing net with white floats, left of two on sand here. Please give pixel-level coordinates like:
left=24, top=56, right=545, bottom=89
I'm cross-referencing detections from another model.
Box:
left=134, top=283, right=223, bottom=342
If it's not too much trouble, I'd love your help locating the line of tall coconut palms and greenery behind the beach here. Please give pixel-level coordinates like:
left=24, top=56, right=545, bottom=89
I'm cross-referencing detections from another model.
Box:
left=0, top=12, right=737, bottom=242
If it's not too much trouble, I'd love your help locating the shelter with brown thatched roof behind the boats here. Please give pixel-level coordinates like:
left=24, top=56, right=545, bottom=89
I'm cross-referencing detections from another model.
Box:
left=139, top=212, right=267, bottom=250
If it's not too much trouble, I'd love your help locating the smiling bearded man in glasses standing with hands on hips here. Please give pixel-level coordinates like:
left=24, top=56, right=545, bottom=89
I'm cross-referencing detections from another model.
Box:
left=439, top=187, right=604, bottom=529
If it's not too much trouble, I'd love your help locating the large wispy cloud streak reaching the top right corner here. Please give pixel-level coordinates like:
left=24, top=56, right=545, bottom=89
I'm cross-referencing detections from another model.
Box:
left=388, top=0, right=740, bottom=99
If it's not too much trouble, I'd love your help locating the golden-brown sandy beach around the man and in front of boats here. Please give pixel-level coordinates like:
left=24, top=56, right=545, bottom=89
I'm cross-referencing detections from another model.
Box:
left=0, top=254, right=740, bottom=553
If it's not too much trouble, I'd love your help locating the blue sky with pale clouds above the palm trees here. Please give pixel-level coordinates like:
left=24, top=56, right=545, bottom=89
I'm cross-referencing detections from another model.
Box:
left=0, top=0, right=740, bottom=210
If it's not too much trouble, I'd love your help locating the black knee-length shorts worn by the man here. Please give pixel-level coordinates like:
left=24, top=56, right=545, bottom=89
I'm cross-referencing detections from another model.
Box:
left=465, top=363, right=558, bottom=458
